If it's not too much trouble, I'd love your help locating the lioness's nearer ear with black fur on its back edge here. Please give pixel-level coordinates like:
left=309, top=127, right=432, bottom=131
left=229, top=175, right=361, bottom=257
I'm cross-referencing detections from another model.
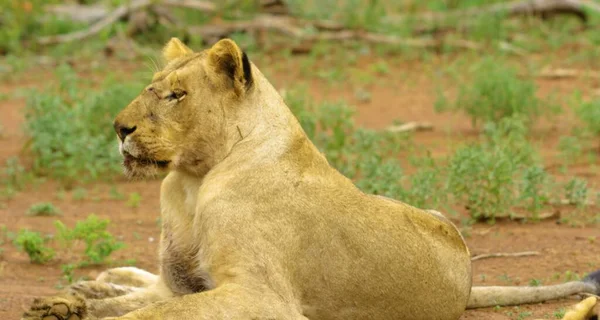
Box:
left=207, top=39, right=253, bottom=95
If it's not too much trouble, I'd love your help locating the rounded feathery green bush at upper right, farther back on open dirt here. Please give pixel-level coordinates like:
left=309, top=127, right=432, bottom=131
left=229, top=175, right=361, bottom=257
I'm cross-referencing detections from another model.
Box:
left=435, top=58, right=560, bottom=126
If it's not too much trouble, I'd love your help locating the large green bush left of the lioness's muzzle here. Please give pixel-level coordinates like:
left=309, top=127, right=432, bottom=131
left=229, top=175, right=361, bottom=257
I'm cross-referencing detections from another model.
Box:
left=25, top=65, right=141, bottom=184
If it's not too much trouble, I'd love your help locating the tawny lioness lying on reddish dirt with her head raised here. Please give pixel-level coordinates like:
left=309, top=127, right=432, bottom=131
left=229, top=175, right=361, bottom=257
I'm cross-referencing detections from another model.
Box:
left=23, top=39, right=600, bottom=320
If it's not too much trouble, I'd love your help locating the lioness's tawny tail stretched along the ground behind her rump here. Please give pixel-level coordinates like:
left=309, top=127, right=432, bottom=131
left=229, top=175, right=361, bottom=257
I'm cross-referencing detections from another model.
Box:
left=467, top=270, right=600, bottom=309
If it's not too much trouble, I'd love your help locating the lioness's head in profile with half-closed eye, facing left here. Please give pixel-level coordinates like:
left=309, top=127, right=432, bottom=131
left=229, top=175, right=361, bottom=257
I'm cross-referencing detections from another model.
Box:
left=114, top=38, right=260, bottom=177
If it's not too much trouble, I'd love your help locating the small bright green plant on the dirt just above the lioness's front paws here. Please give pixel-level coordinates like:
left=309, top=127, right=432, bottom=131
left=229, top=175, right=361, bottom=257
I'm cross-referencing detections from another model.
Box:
left=54, top=214, right=124, bottom=266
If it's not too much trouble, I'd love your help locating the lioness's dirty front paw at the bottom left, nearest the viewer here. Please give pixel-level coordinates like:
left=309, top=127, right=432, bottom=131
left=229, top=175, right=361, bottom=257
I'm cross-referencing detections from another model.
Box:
left=21, top=293, right=87, bottom=320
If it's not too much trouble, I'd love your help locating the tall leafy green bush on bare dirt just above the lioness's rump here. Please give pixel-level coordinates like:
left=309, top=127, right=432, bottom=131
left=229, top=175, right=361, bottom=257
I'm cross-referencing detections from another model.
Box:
left=447, top=117, right=546, bottom=221
